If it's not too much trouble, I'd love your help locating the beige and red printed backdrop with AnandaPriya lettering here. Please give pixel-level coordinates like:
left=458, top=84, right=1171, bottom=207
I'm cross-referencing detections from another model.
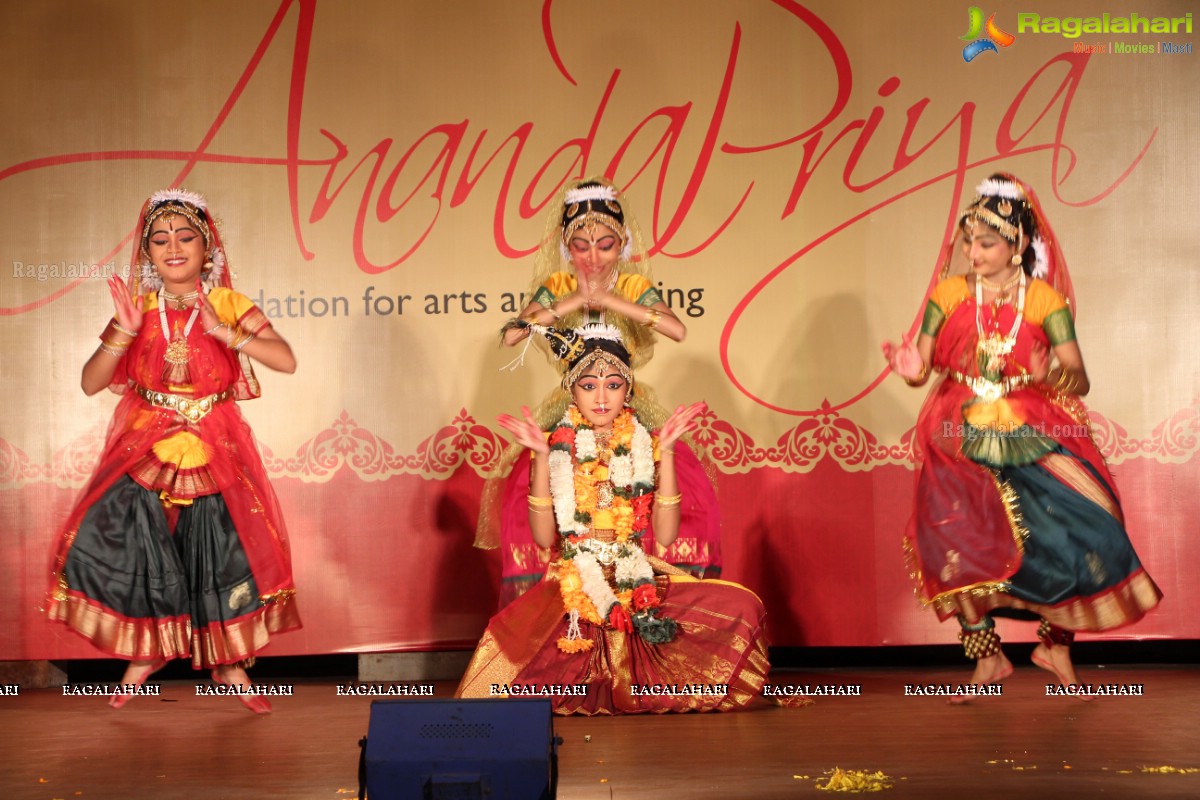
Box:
left=0, top=0, right=1200, bottom=660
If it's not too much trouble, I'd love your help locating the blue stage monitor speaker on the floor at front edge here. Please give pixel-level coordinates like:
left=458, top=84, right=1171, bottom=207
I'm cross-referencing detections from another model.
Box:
left=359, top=698, right=558, bottom=800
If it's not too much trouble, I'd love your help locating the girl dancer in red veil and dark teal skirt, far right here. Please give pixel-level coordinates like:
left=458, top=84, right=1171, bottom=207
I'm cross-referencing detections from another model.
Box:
left=883, top=174, right=1162, bottom=684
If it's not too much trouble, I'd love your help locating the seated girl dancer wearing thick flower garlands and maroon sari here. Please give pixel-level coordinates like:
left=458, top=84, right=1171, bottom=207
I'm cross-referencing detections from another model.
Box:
left=458, top=325, right=769, bottom=715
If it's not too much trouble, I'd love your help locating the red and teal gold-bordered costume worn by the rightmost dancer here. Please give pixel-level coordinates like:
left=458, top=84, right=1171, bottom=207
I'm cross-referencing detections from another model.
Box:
left=905, top=276, right=1162, bottom=631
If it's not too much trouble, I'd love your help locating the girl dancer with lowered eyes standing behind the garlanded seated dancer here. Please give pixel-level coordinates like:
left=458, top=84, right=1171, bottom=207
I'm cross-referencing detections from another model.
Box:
left=475, top=178, right=721, bottom=607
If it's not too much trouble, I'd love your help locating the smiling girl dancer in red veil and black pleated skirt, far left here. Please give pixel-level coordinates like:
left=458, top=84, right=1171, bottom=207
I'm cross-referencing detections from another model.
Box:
left=48, top=190, right=300, bottom=714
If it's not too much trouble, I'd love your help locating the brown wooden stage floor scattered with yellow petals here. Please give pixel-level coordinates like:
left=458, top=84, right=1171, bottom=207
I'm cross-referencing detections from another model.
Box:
left=0, top=666, right=1200, bottom=800
